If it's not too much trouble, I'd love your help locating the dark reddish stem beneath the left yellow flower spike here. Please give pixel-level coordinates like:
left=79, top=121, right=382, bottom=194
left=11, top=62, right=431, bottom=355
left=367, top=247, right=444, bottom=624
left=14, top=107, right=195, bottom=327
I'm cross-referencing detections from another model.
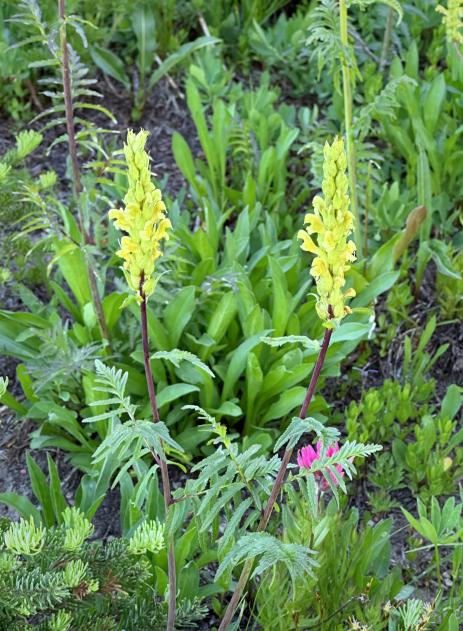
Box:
left=140, top=294, right=177, bottom=631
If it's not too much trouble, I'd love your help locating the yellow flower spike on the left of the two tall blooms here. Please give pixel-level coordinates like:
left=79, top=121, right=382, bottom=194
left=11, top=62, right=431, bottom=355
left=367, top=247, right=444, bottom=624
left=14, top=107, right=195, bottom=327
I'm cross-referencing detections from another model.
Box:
left=109, top=130, right=171, bottom=302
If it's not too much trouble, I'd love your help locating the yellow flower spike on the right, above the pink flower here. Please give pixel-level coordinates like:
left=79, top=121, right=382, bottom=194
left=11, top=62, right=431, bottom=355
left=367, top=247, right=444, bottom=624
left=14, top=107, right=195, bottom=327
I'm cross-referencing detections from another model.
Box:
left=297, top=137, right=355, bottom=322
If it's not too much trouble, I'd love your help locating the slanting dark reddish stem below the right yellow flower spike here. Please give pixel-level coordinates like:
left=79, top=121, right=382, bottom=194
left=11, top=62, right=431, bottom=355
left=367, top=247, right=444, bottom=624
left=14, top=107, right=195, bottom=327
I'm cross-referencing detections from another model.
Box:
left=219, top=329, right=333, bottom=631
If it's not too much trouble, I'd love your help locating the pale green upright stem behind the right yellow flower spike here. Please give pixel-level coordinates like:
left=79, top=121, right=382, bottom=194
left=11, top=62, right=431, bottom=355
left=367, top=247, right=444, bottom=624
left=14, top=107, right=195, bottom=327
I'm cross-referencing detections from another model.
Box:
left=339, top=0, right=363, bottom=259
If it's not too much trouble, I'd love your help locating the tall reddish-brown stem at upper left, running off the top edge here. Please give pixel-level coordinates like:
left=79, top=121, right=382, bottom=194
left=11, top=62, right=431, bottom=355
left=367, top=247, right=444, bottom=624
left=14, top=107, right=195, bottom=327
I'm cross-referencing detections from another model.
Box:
left=58, top=0, right=110, bottom=346
